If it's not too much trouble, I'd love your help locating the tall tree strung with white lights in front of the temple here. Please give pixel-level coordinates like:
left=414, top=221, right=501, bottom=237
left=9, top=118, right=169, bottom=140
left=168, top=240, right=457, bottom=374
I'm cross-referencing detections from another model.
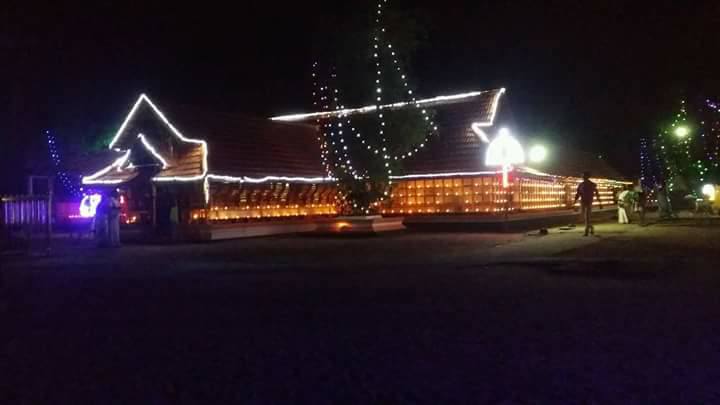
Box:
left=312, top=0, right=437, bottom=215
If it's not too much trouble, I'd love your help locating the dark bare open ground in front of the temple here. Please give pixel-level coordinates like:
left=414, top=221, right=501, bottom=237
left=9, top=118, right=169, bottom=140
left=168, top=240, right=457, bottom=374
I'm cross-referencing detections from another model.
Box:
left=0, top=220, right=720, bottom=404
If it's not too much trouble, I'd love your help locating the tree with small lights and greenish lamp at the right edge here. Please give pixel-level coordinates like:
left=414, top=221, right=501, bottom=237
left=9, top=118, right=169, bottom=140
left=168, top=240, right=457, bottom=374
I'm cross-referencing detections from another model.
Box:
left=640, top=99, right=720, bottom=194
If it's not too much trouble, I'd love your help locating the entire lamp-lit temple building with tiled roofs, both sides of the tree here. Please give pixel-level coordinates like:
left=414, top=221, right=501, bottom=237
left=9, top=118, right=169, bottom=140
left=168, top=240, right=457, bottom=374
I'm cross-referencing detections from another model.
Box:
left=83, top=89, right=626, bottom=237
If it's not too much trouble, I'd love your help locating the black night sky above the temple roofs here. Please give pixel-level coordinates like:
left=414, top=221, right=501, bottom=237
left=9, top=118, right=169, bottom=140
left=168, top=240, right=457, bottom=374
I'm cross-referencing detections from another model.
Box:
left=0, top=0, right=720, bottom=193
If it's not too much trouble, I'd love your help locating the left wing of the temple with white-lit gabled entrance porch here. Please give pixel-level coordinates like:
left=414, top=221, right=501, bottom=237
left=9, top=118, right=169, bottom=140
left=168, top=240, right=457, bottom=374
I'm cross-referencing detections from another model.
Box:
left=83, top=95, right=336, bottom=226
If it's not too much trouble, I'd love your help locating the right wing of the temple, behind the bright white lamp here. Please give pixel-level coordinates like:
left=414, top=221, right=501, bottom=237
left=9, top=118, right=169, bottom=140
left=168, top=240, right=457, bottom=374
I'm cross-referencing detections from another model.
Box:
left=273, top=89, right=627, bottom=217
